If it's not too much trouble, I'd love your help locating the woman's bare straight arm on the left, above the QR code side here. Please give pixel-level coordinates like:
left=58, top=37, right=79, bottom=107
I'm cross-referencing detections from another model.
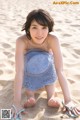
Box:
left=14, top=38, right=25, bottom=106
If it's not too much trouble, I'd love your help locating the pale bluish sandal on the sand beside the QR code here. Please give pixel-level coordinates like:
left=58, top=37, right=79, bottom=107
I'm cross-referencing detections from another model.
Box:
left=11, top=105, right=25, bottom=120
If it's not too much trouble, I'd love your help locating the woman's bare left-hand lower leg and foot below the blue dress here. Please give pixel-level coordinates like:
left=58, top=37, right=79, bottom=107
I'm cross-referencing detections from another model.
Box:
left=24, top=90, right=36, bottom=108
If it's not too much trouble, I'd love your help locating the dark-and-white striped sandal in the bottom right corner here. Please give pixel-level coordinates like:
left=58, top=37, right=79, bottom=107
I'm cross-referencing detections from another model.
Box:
left=62, top=101, right=80, bottom=118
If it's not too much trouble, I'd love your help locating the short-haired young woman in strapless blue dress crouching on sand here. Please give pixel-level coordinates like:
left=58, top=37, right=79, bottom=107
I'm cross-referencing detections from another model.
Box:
left=14, top=9, right=79, bottom=118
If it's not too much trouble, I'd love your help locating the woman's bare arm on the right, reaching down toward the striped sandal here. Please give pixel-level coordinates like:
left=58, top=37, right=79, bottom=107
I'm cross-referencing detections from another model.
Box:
left=50, top=36, right=71, bottom=103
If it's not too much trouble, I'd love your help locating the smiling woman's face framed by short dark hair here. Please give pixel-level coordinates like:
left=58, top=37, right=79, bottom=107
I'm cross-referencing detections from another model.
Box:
left=29, top=20, right=49, bottom=44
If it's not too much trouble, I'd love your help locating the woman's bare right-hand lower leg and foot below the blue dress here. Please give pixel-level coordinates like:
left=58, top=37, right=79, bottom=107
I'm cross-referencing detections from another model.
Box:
left=45, top=84, right=60, bottom=107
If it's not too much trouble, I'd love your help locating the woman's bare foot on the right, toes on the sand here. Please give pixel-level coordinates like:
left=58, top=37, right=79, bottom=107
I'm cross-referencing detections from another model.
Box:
left=48, top=97, right=61, bottom=108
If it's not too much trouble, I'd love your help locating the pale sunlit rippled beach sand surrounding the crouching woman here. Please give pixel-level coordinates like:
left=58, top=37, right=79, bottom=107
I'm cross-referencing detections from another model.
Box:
left=0, top=0, right=80, bottom=120
